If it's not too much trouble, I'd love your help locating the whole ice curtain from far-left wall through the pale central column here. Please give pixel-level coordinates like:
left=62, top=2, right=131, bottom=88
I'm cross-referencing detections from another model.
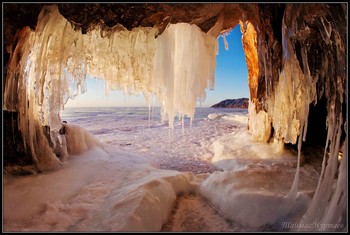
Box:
left=4, top=5, right=217, bottom=170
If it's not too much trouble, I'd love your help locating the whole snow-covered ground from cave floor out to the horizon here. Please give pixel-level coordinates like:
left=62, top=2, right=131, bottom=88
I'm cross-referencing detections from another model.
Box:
left=3, top=108, right=326, bottom=231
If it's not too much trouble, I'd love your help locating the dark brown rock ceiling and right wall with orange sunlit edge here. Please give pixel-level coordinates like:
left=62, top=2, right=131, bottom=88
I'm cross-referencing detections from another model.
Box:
left=3, top=3, right=347, bottom=169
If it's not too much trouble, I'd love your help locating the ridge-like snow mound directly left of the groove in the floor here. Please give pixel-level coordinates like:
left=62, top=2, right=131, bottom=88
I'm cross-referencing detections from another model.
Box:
left=99, top=173, right=198, bottom=231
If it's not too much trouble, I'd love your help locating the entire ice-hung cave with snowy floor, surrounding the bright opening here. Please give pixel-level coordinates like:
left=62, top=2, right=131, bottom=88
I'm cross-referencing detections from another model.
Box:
left=2, top=3, right=348, bottom=232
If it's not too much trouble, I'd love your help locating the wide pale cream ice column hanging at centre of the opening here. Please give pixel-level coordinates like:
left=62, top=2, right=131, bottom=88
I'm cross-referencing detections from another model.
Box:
left=153, top=23, right=217, bottom=127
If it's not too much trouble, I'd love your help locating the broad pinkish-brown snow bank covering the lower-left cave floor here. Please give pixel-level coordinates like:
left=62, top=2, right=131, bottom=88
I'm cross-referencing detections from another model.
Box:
left=4, top=143, right=198, bottom=232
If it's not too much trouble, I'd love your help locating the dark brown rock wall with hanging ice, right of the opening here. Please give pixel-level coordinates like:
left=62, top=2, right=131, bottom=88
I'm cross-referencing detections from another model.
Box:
left=243, top=4, right=347, bottom=147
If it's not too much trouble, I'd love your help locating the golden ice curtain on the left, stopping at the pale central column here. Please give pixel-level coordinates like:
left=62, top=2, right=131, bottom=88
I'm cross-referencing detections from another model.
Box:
left=4, top=5, right=157, bottom=170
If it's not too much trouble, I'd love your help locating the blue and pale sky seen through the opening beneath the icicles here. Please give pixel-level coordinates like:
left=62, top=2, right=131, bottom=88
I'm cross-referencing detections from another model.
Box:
left=65, top=24, right=249, bottom=107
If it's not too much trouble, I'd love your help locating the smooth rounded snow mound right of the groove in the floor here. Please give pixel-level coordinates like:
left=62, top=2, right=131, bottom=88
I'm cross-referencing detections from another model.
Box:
left=200, top=172, right=304, bottom=229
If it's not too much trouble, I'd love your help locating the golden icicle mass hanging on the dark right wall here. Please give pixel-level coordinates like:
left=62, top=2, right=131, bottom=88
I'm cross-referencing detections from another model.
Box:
left=265, top=13, right=316, bottom=144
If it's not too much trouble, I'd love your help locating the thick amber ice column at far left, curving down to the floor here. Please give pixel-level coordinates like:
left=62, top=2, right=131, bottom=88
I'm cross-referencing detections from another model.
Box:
left=4, top=6, right=84, bottom=171
